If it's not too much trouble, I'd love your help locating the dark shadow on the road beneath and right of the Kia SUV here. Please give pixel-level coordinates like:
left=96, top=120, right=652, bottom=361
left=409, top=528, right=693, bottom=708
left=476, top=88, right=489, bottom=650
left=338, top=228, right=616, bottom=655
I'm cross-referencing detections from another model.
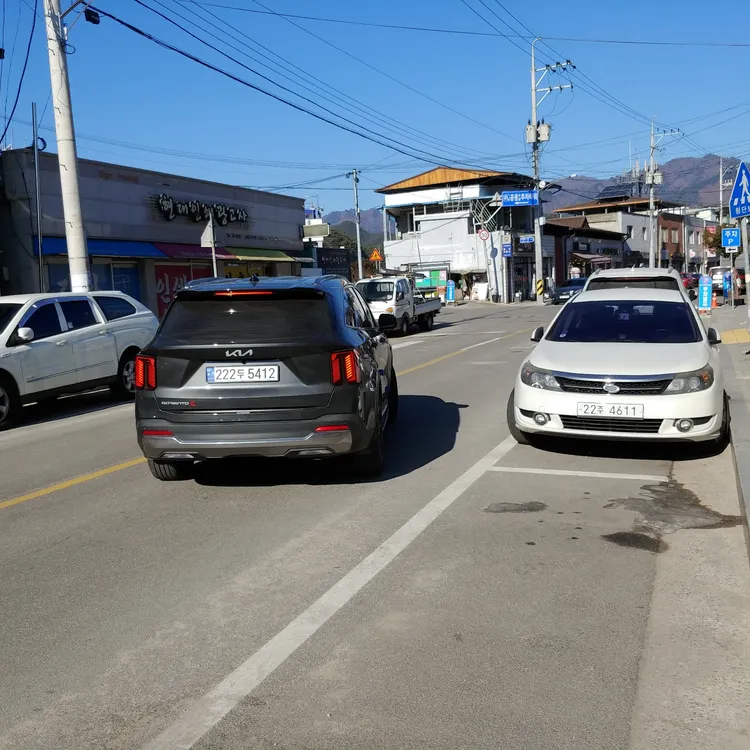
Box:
left=196, top=395, right=466, bottom=487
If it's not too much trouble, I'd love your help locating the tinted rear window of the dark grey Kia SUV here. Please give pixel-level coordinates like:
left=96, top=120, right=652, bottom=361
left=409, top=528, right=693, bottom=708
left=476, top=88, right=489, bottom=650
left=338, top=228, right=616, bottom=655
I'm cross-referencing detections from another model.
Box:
left=159, top=297, right=331, bottom=344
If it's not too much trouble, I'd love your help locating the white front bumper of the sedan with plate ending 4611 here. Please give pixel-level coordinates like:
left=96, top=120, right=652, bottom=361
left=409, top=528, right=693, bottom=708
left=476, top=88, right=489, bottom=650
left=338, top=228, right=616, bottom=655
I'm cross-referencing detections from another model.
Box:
left=514, top=380, right=724, bottom=442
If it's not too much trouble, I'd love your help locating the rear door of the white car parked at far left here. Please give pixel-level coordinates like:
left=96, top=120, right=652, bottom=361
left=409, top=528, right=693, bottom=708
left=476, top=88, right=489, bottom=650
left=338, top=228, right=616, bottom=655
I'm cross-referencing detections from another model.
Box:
left=59, top=297, right=118, bottom=384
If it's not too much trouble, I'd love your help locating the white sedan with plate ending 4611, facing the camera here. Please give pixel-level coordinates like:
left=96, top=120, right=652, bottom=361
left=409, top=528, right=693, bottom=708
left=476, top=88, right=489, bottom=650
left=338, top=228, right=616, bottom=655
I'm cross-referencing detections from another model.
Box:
left=507, top=289, right=729, bottom=444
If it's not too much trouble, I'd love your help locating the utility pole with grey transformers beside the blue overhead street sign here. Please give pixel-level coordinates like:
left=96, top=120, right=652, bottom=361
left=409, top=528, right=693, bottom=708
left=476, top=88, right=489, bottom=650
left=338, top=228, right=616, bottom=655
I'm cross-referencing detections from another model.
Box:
left=526, top=37, right=575, bottom=305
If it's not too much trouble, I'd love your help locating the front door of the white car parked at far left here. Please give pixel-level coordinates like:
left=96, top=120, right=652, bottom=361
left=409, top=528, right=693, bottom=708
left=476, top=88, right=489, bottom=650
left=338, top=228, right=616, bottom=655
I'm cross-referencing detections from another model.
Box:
left=13, top=299, right=76, bottom=395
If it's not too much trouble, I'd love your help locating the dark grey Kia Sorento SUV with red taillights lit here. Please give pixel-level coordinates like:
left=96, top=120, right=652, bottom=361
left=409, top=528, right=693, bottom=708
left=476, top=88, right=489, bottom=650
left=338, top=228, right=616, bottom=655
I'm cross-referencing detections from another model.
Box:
left=135, top=276, right=398, bottom=481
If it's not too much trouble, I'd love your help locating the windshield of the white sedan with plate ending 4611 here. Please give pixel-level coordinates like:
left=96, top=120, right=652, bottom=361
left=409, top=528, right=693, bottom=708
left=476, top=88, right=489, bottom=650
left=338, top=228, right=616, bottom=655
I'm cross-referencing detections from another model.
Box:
left=547, top=300, right=702, bottom=344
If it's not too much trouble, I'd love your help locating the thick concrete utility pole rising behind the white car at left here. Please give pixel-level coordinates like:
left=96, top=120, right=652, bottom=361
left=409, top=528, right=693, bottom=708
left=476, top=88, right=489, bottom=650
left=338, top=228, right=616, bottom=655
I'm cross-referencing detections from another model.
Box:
left=44, top=0, right=90, bottom=292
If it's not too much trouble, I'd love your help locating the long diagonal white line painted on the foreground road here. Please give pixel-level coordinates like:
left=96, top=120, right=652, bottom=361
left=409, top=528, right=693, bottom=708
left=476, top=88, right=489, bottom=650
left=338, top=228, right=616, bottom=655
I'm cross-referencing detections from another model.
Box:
left=143, top=437, right=516, bottom=750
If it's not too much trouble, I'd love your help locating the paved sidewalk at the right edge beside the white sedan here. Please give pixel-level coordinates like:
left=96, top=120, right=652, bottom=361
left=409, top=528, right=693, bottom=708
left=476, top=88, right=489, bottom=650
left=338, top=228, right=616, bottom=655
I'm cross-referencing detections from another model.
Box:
left=704, top=305, right=750, bottom=559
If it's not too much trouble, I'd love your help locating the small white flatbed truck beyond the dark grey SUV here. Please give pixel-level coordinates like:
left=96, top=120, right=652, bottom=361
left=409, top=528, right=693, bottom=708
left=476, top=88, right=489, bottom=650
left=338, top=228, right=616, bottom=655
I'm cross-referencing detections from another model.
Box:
left=357, top=276, right=442, bottom=336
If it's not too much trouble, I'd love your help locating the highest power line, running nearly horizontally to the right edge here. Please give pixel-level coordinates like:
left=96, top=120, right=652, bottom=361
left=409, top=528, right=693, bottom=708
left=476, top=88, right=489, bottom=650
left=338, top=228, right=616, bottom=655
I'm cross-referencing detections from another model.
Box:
left=196, top=2, right=750, bottom=48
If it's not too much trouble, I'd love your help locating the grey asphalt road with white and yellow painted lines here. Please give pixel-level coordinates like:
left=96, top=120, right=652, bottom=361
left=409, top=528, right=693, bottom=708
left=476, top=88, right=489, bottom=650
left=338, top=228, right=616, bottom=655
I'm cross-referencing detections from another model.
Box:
left=0, top=304, right=750, bottom=750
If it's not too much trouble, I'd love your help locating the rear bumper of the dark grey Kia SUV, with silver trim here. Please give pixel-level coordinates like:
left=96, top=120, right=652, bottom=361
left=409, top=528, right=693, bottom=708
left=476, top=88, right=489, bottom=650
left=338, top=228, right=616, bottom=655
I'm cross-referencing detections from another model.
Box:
left=136, top=414, right=371, bottom=461
